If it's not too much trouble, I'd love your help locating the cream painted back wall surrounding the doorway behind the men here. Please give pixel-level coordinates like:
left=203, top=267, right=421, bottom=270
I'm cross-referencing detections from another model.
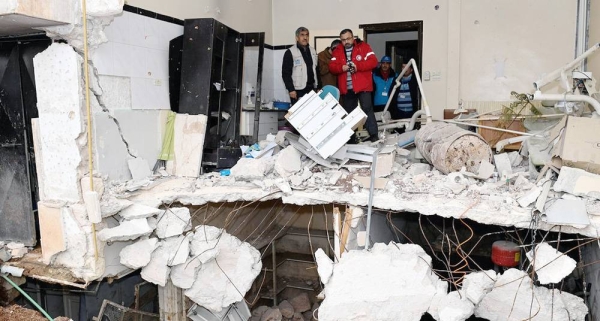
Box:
left=273, top=0, right=577, bottom=118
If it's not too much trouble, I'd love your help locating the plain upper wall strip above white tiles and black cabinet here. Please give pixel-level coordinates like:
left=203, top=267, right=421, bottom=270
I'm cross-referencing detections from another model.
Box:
left=127, top=0, right=273, bottom=44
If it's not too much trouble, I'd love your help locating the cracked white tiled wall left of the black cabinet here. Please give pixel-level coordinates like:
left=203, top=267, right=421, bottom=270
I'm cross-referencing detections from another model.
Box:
left=92, top=12, right=183, bottom=180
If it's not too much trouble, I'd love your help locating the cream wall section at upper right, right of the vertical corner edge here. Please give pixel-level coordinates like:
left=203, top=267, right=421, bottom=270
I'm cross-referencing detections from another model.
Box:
left=460, top=0, right=577, bottom=101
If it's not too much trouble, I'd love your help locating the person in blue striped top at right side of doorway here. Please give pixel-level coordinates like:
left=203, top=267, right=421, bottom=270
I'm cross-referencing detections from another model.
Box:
left=388, top=64, right=419, bottom=119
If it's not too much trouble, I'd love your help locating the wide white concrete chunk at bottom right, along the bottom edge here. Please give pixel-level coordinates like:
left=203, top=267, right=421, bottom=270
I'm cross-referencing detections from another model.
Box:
left=475, top=269, right=588, bottom=321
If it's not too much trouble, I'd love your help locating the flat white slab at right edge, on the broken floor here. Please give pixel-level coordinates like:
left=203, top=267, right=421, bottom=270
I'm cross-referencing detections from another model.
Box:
left=553, top=166, right=600, bottom=199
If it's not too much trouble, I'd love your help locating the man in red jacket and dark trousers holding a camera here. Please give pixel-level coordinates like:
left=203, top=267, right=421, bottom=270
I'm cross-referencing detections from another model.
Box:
left=329, top=29, right=378, bottom=142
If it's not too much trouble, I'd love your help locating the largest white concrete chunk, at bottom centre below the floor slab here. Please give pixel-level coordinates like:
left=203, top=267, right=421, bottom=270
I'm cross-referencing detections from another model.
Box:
left=319, top=243, right=446, bottom=321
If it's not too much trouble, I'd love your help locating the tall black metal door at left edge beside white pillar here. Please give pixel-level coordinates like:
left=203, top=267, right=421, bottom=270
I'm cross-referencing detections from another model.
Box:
left=0, top=36, right=51, bottom=246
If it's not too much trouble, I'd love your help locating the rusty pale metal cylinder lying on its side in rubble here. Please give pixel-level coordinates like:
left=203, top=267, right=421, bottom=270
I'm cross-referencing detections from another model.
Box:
left=415, top=122, right=492, bottom=174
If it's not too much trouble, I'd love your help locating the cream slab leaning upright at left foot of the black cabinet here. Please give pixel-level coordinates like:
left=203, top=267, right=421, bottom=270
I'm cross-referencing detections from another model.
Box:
left=173, top=114, right=208, bottom=177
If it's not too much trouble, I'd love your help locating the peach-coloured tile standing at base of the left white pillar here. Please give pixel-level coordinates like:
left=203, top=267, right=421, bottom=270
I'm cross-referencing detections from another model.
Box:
left=38, top=202, right=67, bottom=264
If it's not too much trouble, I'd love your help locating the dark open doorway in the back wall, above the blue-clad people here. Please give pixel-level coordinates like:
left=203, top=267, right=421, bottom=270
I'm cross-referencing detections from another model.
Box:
left=359, top=21, right=423, bottom=73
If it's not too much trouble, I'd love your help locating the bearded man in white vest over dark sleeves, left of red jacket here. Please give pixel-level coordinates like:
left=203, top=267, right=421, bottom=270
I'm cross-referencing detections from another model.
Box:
left=281, top=27, right=318, bottom=104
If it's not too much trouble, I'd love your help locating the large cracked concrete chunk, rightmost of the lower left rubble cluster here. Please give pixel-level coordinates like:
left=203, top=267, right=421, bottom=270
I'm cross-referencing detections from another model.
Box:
left=185, top=228, right=262, bottom=313
